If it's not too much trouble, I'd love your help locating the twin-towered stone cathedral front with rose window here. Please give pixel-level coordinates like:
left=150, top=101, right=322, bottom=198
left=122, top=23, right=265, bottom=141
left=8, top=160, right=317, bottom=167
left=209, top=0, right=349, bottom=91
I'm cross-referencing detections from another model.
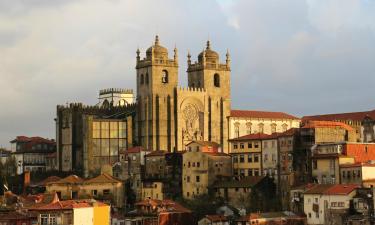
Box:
left=135, top=36, right=231, bottom=152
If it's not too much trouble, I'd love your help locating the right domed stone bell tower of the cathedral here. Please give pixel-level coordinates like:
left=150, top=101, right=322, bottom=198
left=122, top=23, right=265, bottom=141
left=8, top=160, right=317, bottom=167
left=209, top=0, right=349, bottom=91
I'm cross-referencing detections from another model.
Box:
left=187, top=41, right=231, bottom=150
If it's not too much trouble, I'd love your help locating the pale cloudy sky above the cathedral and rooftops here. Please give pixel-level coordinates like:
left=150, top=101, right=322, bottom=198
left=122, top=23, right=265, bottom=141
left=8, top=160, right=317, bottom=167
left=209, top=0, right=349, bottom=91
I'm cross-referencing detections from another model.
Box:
left=0, top=0, right=375, bottom=147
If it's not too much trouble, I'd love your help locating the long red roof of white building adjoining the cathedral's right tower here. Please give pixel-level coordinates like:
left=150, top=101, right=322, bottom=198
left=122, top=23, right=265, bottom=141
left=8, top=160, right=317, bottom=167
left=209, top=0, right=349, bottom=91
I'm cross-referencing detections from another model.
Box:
left=230, top=110, right=299, bottom=120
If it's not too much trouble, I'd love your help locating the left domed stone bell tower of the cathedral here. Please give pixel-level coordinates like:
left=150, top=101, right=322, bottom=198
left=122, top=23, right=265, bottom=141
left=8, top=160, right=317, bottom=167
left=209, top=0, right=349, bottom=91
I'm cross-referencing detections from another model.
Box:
left=136, top=36, right=178, bottom=151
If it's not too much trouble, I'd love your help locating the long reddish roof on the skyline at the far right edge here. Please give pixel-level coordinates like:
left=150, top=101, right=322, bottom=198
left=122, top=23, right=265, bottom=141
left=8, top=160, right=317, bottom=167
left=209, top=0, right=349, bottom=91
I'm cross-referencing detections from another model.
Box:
left=302, top=110, right=375, bottom=121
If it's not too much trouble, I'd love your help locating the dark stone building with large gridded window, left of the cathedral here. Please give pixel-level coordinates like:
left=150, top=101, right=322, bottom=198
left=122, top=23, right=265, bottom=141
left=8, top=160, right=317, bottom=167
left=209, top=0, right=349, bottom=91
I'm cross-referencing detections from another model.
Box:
left=55, top=100, right=135, bottom=177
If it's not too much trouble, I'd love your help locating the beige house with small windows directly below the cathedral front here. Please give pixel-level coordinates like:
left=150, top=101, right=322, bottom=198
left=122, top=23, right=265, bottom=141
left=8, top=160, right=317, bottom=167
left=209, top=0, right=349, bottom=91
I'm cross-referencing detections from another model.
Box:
left=182, top=142, right=232, bottom=198
